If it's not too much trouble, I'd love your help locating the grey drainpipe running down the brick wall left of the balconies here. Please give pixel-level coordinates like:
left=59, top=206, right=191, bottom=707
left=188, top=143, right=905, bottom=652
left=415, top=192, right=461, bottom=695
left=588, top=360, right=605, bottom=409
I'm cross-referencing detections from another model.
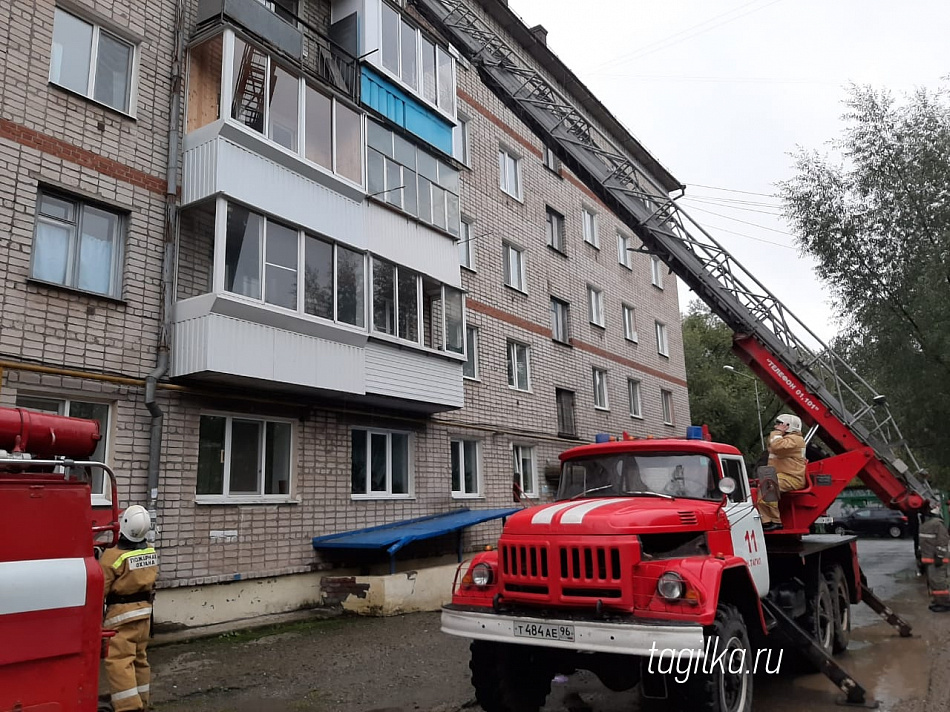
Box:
left=145, top=0, right=185, bottom=533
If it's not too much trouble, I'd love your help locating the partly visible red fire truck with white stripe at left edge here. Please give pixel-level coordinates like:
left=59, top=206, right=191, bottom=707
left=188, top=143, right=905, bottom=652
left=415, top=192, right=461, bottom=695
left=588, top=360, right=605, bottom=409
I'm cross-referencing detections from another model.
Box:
left=0, top=408, right=119, bottom=712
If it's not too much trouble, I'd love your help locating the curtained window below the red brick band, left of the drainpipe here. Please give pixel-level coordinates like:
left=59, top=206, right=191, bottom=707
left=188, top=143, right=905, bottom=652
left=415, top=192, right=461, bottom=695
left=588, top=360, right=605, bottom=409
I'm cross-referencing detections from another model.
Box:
left=30, top=190, right=126, bottom=298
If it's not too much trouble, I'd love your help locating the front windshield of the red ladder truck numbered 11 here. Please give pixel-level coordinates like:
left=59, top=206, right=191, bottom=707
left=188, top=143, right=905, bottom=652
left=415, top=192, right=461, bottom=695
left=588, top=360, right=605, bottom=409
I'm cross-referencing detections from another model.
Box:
left=557, top=453, right=722, bottom=501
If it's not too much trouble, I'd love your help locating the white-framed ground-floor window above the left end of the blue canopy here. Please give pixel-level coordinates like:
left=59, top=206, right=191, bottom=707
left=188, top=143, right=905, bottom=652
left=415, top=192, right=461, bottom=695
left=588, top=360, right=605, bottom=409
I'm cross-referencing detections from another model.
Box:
left=350, top=429, right=412, bottom=498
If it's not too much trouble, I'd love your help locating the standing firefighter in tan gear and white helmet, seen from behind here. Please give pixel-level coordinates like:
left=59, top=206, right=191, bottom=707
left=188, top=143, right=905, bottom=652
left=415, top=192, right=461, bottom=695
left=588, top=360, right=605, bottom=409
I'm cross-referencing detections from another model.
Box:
left=99, top=504, right=158, bottom=712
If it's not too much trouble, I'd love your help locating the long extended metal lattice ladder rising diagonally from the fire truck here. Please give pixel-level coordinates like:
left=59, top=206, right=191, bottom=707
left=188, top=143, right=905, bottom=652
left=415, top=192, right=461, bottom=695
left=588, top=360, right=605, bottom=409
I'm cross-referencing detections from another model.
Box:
left=413, top=0, right=932, bottom=506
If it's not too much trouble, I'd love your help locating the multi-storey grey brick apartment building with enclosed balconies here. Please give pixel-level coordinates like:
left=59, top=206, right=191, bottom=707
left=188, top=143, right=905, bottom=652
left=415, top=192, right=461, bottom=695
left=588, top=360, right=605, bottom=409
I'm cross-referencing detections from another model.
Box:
left=0, top=0, right=689, bottom=625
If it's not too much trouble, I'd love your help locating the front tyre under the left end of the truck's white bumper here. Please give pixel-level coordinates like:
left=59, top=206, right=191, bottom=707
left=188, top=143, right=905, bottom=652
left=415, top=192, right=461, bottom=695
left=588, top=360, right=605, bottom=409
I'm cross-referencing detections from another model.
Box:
left=469, top=640, right=554, bottom=712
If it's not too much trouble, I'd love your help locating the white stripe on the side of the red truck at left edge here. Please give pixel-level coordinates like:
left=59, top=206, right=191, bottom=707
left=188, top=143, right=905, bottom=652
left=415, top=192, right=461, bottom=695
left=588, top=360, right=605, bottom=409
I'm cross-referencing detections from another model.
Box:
left=0, top=558, right=86, bottom=615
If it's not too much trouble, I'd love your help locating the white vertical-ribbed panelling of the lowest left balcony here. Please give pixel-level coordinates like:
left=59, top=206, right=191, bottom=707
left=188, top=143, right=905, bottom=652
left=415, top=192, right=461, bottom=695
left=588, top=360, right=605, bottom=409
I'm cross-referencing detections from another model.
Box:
left=172, top=314, right=366, bottom=394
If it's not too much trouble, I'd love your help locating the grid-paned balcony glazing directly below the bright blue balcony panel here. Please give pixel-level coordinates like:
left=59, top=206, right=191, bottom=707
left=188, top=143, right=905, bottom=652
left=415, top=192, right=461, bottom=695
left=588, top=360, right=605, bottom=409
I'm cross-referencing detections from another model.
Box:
left=366, top=121, right=461, bottom=236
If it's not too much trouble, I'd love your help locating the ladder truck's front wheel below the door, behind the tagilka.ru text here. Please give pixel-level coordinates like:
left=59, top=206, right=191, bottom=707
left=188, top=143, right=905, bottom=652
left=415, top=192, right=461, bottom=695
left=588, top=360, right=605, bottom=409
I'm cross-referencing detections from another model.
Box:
left=670, top=603, right=752, bottom=712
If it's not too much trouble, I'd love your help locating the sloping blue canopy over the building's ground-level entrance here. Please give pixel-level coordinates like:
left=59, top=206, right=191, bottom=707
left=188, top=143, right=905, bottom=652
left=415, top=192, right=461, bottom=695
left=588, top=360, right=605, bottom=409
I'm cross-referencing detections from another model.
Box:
left=313, top=507, right=521, bottom=572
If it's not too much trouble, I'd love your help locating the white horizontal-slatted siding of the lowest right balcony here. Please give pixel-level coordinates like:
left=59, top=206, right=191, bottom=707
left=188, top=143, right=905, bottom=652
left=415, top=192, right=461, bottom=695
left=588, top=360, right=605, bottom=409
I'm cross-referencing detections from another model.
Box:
left=366, top=341, right=465, bottom=408
